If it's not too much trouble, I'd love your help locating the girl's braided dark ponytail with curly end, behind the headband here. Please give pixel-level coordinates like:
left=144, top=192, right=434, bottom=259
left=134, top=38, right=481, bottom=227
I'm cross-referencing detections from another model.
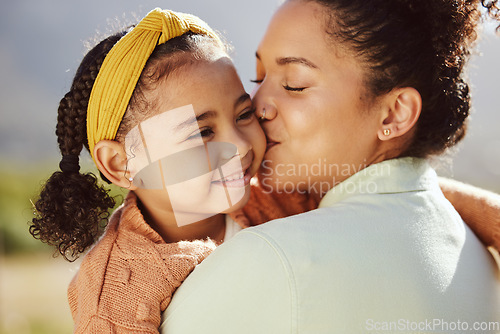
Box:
left=30, top=32, right=125, bottom=261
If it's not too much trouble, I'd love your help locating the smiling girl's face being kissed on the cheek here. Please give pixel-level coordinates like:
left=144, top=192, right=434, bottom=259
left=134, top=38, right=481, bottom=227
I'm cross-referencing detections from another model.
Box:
left=129, top=55, right=266, bottom=225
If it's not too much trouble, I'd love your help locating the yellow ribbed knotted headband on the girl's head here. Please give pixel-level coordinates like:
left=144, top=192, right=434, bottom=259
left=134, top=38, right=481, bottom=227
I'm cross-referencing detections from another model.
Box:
left=87, top=8, right=219, bottom=158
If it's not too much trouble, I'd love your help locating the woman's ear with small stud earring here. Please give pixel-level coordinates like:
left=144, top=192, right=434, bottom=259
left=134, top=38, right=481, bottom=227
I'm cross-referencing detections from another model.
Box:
left=377, top=87, right=422, bottom=141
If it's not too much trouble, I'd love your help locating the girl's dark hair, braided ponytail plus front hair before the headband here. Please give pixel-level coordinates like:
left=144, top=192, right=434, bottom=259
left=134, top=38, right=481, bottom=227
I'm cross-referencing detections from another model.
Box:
left=29, top=31, right=226, bottom=261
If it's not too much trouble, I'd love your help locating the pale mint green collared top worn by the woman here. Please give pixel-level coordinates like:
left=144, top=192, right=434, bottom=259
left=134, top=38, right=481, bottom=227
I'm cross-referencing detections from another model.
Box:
left=161, top=158, right=500, bottom=334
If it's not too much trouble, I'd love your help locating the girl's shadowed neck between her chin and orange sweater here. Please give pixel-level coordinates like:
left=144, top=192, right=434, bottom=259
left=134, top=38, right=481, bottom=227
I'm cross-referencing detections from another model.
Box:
left=137, top=192, right=226, bottom=244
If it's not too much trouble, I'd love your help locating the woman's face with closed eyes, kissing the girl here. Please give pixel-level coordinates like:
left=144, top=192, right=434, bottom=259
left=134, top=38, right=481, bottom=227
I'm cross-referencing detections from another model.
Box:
left=253, top=0, right=380, bottom=194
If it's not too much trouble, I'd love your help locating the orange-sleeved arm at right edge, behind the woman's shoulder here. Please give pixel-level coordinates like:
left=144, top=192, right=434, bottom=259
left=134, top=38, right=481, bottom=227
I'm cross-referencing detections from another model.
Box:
left=439, top=178, right=500, bottom=251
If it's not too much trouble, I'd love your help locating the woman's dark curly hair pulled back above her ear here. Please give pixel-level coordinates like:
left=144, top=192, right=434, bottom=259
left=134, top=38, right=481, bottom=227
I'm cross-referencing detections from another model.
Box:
left=305, top=0, right=500, bottom=157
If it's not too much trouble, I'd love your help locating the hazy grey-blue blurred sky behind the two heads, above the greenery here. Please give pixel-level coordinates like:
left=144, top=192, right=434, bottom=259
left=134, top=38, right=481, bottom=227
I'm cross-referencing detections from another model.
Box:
left=0, top=0, right=500, bottom=191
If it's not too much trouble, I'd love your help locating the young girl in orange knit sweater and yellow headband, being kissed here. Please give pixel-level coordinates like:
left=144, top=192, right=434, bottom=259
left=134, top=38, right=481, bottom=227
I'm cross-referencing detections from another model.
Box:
left=30, top=9, right=265, bottom=333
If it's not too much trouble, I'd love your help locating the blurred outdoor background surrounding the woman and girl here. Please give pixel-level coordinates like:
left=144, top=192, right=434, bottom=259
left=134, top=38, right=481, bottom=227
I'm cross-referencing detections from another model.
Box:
left=0, top=0, right=500, bottom=334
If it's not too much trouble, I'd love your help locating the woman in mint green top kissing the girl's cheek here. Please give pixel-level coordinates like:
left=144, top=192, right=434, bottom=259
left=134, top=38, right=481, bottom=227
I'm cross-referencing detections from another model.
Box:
left=163, top=0, right=500, bottom=333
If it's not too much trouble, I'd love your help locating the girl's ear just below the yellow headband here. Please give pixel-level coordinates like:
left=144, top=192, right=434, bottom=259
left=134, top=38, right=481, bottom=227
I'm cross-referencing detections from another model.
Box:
left=94, top=140, right=135, bottom=190
